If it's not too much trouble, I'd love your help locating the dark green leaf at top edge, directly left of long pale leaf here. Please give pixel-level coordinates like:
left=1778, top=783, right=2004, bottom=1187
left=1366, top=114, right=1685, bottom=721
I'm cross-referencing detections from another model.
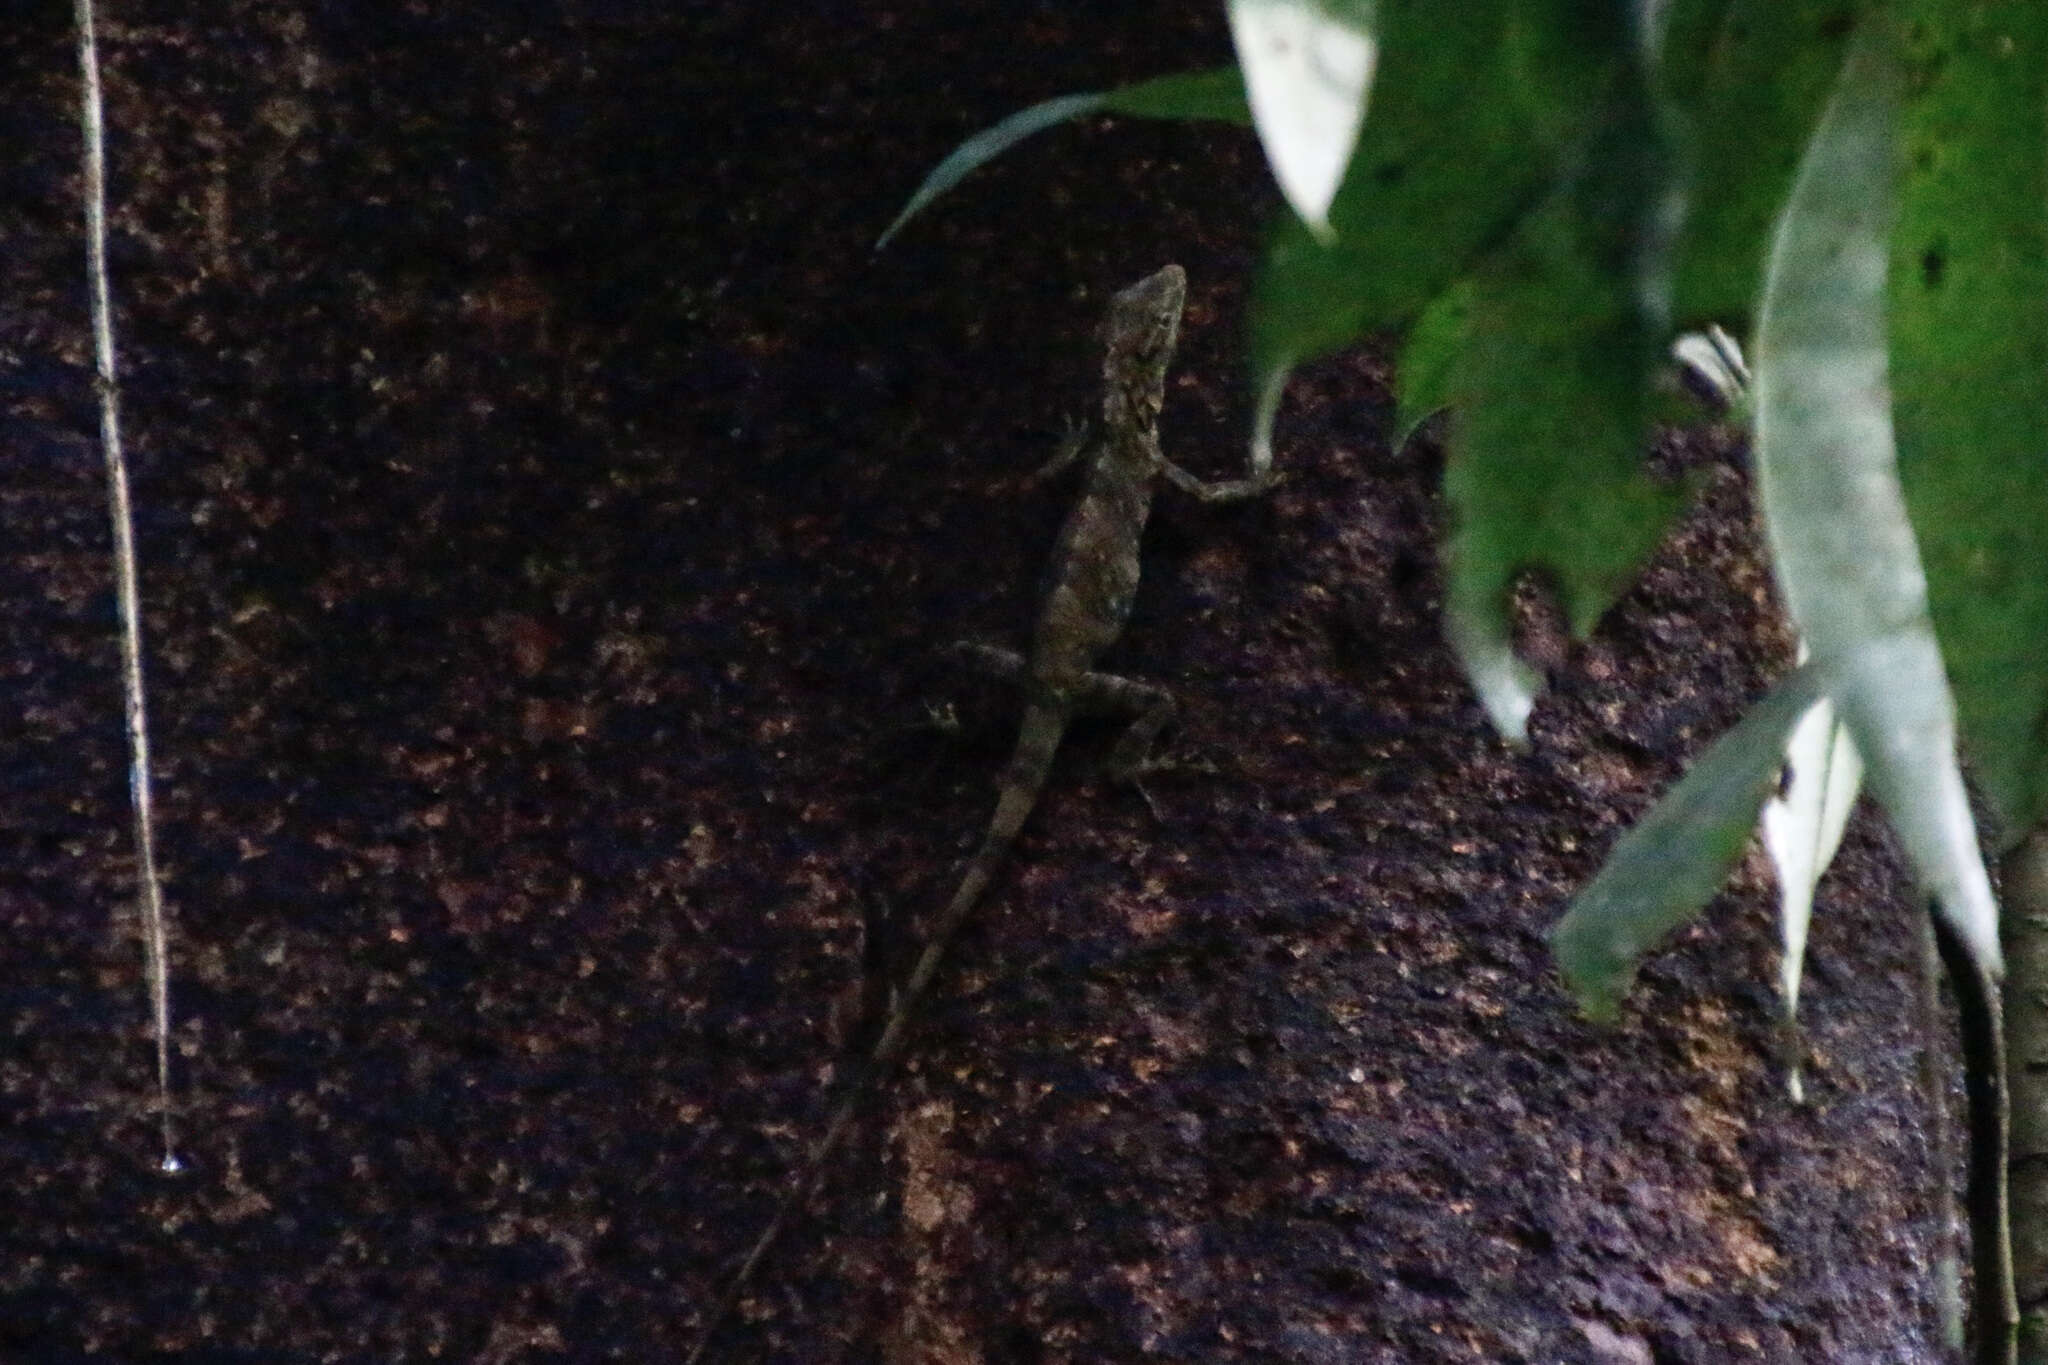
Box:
left=1665, top=0, right=1862, bottom=334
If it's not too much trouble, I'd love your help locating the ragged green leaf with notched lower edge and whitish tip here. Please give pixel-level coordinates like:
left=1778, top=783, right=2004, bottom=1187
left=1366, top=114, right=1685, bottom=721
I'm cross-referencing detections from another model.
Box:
left=1444, top=53, right=1681, bottom=743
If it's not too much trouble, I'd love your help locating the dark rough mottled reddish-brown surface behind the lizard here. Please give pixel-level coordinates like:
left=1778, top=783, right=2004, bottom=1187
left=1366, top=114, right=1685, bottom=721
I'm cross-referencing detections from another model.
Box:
left=0, top=0, right=1966, bottom=1365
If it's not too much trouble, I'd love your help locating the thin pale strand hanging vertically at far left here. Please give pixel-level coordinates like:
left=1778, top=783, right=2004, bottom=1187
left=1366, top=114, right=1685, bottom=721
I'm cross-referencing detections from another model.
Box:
left=78, top=0, right=182, bottom=1173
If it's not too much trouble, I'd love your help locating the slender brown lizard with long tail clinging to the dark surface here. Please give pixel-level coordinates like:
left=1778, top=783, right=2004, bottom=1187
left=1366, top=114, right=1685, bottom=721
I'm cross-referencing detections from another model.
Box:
left=686, top=266, right=1278, bottom=1365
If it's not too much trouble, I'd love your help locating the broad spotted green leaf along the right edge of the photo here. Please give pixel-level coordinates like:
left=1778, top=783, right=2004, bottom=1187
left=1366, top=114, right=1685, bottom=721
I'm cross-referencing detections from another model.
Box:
left=1886, top=0, right=2048, bottom=843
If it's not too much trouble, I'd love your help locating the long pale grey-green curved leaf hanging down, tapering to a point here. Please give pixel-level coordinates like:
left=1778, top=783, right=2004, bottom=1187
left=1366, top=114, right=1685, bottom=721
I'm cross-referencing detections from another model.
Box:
left=1755, top=23, right=1999, bottom=974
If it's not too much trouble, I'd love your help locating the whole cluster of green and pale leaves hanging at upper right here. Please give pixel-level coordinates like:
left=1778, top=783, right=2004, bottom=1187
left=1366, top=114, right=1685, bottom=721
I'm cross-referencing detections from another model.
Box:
left=885, top=0, right=2048, bottom=1047
